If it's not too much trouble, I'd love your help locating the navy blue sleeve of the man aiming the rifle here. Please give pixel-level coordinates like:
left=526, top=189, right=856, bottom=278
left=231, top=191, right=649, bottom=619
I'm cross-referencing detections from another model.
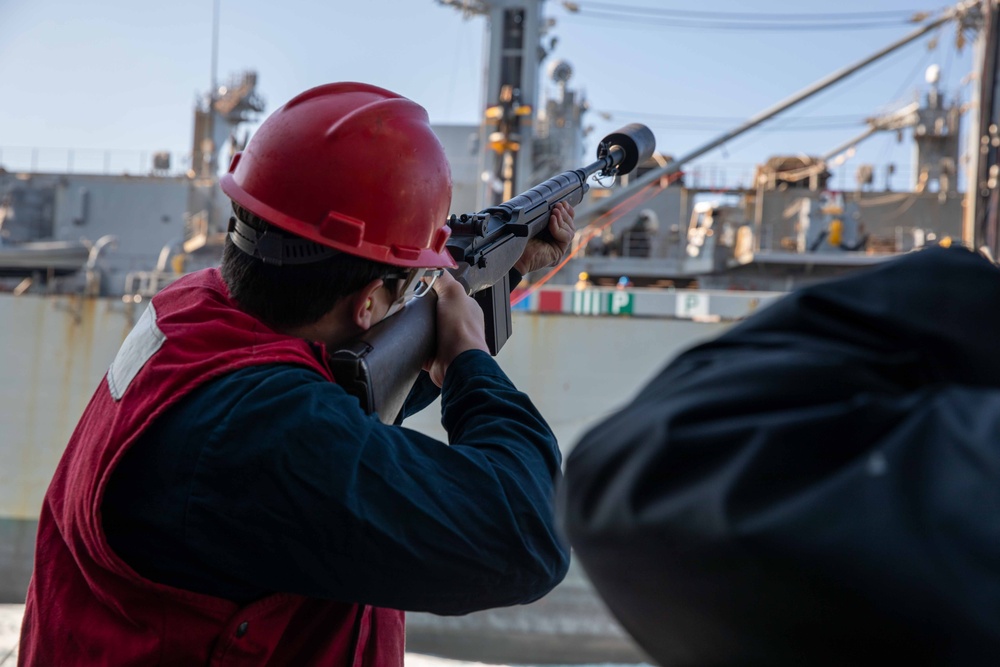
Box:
left=103, top=351, right=568, bottom=614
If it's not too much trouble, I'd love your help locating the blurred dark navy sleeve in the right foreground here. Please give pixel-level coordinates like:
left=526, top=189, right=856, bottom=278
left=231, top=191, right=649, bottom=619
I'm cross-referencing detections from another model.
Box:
left=560, top=248, right=1000, bottom=665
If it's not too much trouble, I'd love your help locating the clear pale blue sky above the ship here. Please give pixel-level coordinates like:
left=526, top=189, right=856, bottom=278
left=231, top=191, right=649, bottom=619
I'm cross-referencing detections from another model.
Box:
left=0, top=0, right=972, bottom=188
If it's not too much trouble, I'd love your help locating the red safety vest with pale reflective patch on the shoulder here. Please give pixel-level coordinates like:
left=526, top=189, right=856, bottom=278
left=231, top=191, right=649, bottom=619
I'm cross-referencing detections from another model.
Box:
left=19, top=269, right=404, bottom=667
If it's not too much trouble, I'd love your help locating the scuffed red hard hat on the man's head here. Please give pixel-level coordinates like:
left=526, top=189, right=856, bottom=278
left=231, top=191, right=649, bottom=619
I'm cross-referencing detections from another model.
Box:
left=222, top=83, right=455, bottom=267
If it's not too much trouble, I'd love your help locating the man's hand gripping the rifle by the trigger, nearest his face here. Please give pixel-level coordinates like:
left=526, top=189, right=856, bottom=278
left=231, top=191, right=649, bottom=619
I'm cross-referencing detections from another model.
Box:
left=424, top=271, right=489, bottom=387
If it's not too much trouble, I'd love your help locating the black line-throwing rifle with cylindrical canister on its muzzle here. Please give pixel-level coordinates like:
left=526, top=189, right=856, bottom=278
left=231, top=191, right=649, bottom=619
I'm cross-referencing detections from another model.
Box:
left=329, top=123, right=656, bottom=424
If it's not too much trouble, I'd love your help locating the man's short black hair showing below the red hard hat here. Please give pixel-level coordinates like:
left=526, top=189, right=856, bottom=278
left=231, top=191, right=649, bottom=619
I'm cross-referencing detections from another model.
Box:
left=221, top=203, right=399, bottom=330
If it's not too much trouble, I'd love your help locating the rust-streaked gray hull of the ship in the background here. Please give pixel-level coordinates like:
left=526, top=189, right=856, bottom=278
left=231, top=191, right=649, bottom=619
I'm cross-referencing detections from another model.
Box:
left=0, top=292, right=736, bottom=664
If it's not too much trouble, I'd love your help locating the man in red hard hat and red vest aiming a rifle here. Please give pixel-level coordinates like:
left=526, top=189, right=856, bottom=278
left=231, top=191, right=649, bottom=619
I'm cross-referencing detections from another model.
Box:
left=20, top=83, right=573, bottom=665
